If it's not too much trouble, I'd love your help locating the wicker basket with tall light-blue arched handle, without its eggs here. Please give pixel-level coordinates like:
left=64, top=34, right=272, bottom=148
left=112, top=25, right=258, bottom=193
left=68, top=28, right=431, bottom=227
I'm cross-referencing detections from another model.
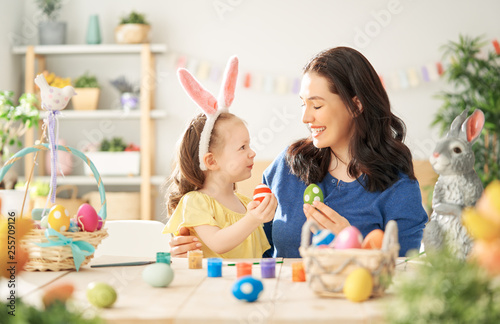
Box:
left=0, top=144, right=108, bottom=271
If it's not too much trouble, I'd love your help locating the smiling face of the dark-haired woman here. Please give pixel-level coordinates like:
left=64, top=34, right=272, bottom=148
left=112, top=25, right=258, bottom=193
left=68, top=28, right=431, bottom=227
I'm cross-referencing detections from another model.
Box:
left=300, top=72, right=354, bottom=152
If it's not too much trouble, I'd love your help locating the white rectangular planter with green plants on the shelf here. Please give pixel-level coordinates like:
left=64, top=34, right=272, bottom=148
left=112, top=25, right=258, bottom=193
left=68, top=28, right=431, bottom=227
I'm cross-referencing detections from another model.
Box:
left=85, top=137, right=141, bottom=176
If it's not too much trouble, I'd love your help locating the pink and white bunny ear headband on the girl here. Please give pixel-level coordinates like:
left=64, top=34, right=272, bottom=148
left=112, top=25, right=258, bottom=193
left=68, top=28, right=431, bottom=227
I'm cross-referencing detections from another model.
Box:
left=177, top=56, right=238, bottom=171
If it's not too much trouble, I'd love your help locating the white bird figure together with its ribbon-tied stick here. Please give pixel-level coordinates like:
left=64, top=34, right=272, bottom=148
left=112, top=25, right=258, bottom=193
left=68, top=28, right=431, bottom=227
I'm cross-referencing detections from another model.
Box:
left=35, top=74, right=76, bottom=203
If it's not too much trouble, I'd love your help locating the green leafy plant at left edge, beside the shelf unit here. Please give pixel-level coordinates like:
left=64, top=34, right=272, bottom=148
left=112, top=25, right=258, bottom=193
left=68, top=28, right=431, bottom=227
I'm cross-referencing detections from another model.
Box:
left=0, top=91, right=40, bottom=160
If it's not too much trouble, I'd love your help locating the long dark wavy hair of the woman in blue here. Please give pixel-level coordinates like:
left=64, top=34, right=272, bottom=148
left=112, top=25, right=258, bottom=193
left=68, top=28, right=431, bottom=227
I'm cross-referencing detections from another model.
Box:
left=286, top=47, right=415, bottom=192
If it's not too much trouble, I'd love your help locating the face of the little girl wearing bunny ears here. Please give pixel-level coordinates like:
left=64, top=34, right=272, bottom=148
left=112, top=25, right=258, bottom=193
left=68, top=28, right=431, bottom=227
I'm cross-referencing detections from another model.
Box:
left=214, top=118, right=255, bottom=183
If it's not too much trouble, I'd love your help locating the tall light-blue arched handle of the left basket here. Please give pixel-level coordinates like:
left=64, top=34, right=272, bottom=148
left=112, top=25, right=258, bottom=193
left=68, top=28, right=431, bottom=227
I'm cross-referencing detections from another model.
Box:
left=0, top=143, right=107, bottom=221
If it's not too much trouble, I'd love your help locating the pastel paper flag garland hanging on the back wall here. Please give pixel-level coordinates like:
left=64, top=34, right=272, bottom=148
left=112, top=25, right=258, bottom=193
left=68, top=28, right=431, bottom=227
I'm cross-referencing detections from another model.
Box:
left=171, top=39, right=500, bottom=95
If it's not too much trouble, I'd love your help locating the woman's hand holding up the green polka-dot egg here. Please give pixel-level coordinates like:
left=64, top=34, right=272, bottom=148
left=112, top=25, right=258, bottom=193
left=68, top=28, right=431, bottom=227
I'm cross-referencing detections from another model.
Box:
left=303, top=201, right=351, bottom=235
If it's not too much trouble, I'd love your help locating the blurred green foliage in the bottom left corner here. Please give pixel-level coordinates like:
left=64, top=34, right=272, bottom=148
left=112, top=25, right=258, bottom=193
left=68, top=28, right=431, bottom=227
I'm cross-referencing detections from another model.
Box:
left=0, top=298, right=104, bottom=324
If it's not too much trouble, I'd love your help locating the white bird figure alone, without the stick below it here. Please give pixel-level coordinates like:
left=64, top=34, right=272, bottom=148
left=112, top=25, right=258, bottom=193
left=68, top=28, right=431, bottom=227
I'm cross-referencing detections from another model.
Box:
left=35, top=74, right=76, bottom=111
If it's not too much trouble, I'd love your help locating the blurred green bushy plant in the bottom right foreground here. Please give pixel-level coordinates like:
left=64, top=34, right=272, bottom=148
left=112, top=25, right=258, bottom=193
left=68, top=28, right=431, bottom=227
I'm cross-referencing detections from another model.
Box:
left=387, top=250, right=500, bottom=324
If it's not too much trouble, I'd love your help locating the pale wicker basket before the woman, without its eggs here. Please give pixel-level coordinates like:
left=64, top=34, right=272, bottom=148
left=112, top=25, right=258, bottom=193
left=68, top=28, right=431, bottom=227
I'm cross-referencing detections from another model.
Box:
left=299, top=220, right=399, bottom=297
